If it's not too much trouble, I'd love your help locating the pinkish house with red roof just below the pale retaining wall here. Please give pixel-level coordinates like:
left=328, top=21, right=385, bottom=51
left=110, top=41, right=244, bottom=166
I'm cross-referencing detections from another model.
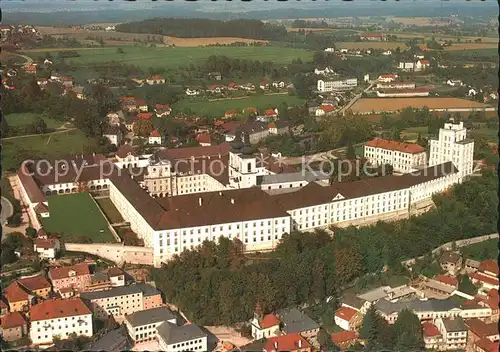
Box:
left=49, top=263, right=90, bottom=292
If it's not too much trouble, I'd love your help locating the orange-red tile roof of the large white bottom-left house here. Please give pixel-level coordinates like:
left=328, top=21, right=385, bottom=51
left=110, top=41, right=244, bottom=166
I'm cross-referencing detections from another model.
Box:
left=30, top=298, right=92, bottom=322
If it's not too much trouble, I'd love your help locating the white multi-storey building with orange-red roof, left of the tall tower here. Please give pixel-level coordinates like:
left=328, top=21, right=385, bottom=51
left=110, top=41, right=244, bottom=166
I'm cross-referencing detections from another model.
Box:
left=364, top=138, right=427, bottom=173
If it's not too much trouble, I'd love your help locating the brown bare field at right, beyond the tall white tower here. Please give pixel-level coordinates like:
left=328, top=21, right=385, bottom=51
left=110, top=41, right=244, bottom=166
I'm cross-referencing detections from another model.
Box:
left=351, top=98, right=494, bottom=114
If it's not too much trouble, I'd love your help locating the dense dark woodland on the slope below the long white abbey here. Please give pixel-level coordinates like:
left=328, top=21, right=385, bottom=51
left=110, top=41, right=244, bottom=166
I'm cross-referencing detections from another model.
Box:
left=152, top=170, right=498, bottom=325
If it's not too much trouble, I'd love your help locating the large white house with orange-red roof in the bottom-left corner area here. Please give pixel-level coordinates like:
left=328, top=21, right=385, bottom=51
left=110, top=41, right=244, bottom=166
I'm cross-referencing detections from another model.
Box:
left=30, top=298, right=93, bottom=345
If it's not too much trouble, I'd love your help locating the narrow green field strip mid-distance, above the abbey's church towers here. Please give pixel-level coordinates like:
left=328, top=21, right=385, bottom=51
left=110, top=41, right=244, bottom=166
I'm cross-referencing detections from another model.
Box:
left=172, top=95, right=304, bottom=116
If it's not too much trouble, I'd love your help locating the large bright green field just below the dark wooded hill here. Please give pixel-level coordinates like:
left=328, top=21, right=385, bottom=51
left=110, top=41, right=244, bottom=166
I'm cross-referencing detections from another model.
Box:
left=25, top=46, right=313, bottom=70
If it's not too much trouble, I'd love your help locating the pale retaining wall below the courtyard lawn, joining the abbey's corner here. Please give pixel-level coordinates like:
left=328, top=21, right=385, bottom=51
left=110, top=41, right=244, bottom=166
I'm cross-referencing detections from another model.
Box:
left=64, top=243, right=153, bottom=265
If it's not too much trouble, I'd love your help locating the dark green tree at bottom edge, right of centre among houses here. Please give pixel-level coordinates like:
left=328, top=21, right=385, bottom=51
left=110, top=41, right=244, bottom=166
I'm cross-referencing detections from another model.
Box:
left=393, top=309, right=424, bottom=351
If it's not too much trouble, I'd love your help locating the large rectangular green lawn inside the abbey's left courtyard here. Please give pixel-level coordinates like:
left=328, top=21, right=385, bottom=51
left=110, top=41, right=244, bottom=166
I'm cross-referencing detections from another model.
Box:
left=42, top=193, right=116, bottom=242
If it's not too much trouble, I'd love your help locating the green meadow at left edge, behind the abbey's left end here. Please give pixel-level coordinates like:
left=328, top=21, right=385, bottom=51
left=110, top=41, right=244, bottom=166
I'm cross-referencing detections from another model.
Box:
left=2, top=130, right=87, bottom=170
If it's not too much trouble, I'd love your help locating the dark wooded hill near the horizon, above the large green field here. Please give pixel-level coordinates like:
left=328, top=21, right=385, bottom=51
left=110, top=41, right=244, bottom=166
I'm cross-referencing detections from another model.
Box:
left=116, top=18, right=287, bottom=40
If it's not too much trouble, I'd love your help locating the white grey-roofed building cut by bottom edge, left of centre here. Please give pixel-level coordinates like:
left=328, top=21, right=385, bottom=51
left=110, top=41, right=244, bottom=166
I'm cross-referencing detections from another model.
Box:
left=156, top=322, right=208, bottom=351
